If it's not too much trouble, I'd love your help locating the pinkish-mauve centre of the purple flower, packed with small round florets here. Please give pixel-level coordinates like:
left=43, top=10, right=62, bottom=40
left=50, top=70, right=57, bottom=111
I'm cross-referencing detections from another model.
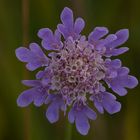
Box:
left=50, top=37, right=105, bottom=105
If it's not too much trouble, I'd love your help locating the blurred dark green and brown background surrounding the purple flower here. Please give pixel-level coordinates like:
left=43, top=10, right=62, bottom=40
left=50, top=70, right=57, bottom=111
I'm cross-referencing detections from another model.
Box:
left=0, top=0, right=140, bottom=140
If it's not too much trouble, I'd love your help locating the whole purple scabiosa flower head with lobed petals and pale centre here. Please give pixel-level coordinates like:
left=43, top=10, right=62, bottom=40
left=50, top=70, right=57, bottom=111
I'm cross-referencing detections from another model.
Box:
left=16, top=7, right=138, bottom=135
